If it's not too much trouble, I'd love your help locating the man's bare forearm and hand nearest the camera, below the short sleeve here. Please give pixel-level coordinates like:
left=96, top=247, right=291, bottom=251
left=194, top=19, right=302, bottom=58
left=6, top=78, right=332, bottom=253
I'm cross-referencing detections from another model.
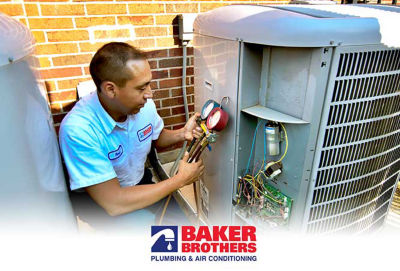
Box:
left=85, top=154, right=204, bottom=216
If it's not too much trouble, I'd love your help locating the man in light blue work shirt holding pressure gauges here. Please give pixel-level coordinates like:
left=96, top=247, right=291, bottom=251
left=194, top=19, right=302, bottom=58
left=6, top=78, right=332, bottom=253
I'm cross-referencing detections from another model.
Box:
left=60, top=42, right=204, bottom=232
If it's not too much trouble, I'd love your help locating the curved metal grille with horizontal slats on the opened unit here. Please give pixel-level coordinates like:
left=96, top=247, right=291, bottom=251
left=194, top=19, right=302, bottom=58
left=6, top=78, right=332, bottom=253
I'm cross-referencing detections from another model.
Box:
left=307, top=49, right=400, bottom=233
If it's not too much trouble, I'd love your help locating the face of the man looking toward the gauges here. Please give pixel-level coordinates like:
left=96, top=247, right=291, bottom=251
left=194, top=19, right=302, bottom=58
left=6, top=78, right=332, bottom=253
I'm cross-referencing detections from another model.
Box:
left=116, top=60, right=153, bottom=115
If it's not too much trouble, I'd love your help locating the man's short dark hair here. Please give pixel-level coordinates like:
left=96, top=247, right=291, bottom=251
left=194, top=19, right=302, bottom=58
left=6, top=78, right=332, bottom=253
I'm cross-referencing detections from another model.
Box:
left=89, top=42, right=147, bottom=92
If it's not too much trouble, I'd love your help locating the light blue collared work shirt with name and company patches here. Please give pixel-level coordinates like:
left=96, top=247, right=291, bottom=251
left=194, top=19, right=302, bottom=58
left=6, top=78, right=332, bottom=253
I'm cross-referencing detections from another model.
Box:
left=59, top=92, right=164, bottom=190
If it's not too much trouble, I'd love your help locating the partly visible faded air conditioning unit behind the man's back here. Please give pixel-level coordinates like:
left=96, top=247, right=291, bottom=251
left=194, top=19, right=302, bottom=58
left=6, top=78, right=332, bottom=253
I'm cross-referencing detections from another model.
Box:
left=0, top=13, right=77, bottom=234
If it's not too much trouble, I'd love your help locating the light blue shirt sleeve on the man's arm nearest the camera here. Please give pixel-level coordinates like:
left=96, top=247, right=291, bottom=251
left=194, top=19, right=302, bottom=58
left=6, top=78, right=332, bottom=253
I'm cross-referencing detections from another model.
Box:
left=59, top=126, right=117, bottom=190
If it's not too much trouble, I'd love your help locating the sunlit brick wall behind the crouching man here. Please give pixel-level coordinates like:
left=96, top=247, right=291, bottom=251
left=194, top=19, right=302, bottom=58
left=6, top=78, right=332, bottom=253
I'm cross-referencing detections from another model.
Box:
left=0, top=0, right=296, bottom=140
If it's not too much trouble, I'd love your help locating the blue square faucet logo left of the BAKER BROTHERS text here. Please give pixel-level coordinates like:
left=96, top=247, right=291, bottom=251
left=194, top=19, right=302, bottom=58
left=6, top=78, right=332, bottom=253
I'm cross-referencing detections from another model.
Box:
left=151, top=226, right=178, bottom=252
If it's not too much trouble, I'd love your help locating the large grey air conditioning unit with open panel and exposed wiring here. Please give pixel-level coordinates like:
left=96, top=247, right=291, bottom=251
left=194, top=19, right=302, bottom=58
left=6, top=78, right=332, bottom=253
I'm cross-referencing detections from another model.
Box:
left=194, top=5, right=400, bottom=234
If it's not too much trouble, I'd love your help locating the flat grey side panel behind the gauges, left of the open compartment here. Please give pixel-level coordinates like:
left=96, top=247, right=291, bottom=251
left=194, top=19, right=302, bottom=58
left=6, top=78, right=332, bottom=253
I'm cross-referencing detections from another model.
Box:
left=194, top=34, right=239, bottom=225
